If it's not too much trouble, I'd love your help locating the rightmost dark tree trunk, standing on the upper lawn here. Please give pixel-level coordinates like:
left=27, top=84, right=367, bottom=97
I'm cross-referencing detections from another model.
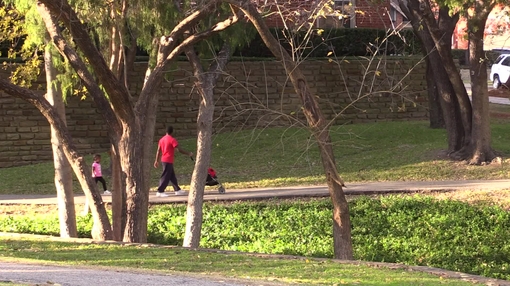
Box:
left=465, top=8, right=496, bottom=165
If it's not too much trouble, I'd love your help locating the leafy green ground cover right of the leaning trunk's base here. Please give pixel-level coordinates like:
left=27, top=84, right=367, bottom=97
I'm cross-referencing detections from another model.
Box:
left=351, top=197, right=510, bottom=279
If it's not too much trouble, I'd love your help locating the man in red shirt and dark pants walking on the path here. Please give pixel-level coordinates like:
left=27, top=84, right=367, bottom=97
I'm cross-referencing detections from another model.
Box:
left=154, top=126, right=193, bottom=197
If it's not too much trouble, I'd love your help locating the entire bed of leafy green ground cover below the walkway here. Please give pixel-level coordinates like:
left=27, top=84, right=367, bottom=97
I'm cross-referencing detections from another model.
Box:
left=0, top=196, right=510, bottom=279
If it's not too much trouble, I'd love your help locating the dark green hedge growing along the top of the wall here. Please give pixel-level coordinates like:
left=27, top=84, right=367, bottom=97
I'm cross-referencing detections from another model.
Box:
left=235, top=29, right=421, bottom=57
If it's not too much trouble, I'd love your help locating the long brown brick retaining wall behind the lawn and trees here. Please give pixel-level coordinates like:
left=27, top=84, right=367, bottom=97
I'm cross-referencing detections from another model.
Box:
left=0, top=58, right=428, bottom=167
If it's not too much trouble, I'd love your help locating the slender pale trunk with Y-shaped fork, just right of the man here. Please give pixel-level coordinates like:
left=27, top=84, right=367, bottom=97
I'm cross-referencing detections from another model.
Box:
left=183, top=44, right=230, bottom=247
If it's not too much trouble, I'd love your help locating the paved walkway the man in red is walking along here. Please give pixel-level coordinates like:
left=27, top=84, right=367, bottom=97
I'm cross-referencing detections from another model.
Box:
left=0, top=179, right=510, bottom=205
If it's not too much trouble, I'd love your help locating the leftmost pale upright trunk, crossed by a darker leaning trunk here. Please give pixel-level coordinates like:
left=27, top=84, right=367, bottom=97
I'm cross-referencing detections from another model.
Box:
left=44, top=35, right=78, bottom=237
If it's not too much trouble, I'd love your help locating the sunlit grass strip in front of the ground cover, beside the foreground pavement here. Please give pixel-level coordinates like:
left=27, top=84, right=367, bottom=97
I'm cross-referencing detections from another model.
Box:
left=0, top=236, right=490, bottom=286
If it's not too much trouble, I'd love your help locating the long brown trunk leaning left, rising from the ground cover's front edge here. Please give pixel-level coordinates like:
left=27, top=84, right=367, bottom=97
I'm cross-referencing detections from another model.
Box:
left=228, top=0, right=353, bottom=259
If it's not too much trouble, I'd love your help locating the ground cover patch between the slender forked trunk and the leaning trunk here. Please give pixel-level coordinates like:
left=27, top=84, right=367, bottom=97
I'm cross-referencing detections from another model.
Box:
left=201, top=201, right=332, bottom=257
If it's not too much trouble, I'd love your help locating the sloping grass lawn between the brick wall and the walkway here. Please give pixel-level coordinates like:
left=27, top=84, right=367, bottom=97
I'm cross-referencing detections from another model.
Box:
left=0, top=105, right=510, bottom=194
